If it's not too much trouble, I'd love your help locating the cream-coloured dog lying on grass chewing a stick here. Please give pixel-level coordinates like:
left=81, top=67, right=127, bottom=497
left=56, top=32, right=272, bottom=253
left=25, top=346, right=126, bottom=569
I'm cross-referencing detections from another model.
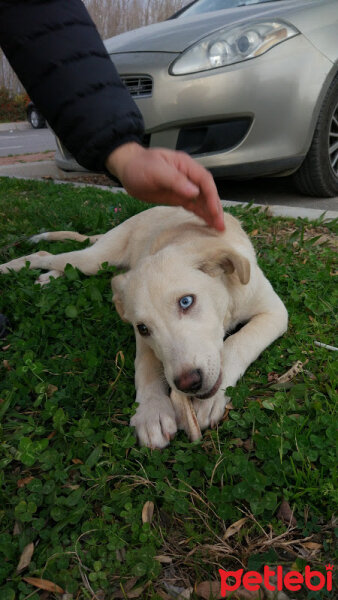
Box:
left=0, top=207, right=287, bottom=448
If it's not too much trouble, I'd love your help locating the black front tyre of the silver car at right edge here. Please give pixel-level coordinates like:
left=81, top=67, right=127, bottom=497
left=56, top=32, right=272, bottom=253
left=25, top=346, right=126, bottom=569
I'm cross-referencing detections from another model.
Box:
left=293, top=76, right=338, bottom=198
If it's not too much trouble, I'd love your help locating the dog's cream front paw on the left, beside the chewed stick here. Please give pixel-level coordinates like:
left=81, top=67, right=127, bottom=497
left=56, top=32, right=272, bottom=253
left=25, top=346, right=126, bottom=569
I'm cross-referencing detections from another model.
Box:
left=130, top=398, right=177, bottom=448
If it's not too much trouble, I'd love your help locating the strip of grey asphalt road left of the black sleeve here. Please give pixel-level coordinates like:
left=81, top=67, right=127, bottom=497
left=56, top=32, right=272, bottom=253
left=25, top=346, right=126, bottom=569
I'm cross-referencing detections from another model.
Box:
left=0, top=129, right=56, bottom=156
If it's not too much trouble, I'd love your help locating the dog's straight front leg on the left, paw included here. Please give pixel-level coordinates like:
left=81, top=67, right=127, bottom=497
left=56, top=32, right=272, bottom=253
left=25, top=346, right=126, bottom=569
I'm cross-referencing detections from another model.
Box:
left=130, top=336, right=177, bottom=448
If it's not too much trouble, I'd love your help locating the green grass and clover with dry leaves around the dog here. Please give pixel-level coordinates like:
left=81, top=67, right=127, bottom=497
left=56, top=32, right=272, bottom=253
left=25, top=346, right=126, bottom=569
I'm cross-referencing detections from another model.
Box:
left=0, top=179, right=338, bottom=600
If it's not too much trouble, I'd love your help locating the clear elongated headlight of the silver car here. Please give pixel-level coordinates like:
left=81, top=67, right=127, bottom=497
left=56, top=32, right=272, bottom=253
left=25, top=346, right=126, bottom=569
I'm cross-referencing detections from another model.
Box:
left=169, top=21, right=299, bottom=75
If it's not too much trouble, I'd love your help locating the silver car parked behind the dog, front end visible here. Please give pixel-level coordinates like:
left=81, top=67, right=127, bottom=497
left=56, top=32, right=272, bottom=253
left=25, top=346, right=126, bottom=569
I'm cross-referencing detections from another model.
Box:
left=58, top=0, right=338, bottom=197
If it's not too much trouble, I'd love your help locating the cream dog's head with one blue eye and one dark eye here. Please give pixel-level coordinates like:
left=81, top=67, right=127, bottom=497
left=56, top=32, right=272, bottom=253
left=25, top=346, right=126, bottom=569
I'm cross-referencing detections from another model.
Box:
left=112, top=244, right=250, bottom=399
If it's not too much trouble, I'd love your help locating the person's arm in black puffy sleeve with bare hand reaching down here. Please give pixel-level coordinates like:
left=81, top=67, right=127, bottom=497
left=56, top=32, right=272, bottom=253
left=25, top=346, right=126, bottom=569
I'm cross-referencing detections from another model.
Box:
left=0, top=0, right=224, bottom=230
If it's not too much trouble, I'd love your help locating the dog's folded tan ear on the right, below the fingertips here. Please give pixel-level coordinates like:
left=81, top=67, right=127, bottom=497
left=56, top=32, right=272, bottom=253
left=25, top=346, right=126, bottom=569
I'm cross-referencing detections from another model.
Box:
left=198, top=248, right=250, bottom=285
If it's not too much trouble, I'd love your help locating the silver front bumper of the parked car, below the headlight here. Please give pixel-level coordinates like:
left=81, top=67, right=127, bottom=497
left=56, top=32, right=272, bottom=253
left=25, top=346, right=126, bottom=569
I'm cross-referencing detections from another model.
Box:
left=111, top=35, right=333, bottom=176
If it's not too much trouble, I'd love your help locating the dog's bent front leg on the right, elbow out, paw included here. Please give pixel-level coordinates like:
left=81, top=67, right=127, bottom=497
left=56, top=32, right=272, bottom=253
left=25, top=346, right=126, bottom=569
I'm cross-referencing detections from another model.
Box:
left=194, top=302, right=287, bottom=429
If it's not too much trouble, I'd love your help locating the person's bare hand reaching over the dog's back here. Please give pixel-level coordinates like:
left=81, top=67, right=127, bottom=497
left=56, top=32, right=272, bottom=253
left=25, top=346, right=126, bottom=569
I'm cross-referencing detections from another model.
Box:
left=106, top=142, right=224, bottom=231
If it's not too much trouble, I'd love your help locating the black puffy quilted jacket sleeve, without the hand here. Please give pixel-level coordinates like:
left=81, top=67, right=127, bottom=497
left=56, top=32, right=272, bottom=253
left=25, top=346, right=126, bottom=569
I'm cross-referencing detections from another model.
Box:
left=0, top=0, right=143, bottom=171
